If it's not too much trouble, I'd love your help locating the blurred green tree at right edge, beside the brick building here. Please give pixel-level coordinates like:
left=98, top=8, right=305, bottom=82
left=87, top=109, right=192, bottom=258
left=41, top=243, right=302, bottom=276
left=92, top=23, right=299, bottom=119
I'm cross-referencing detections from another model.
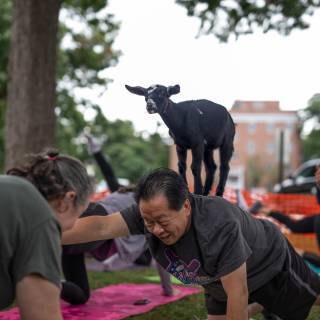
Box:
left=300, top=94, right=320, bottom=160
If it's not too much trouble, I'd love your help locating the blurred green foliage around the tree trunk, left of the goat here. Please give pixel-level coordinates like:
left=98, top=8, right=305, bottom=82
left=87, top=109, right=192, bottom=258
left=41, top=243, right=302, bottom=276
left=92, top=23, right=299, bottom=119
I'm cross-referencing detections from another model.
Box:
left=0, top=0, right=168, bottom=181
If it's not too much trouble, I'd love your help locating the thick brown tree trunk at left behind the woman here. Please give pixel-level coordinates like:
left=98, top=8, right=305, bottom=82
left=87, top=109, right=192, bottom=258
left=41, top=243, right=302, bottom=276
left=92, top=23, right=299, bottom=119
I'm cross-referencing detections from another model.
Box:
left=5, top=0, right=60, bottom=169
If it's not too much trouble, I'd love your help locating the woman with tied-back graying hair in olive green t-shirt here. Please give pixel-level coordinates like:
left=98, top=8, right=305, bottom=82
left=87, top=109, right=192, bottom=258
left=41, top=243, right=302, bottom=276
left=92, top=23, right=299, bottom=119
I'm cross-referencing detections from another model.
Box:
left=0, top=150, right=93, bottom=320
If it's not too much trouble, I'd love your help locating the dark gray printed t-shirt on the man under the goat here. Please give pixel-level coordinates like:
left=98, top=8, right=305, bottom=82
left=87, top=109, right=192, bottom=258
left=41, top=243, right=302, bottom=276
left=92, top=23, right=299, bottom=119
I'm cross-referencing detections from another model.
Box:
left=121, top=194, right=287, bottom=301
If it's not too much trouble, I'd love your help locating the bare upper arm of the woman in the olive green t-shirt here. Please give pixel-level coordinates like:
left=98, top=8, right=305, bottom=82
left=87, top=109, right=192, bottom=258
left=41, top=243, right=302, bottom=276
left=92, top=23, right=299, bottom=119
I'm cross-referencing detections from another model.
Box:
left=16, top=275, right=62, bottom=320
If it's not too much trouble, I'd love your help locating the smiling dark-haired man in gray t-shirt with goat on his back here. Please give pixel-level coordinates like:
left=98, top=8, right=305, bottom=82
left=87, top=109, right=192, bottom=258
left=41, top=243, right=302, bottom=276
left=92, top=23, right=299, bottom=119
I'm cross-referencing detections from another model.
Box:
left=63, top=169, right=320, bottom=320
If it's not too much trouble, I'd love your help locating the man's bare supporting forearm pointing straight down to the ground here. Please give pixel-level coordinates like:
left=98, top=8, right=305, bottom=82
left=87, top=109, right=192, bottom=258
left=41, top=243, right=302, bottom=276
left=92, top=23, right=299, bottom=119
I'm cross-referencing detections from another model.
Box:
left=221, top=263, right=248, bottom=320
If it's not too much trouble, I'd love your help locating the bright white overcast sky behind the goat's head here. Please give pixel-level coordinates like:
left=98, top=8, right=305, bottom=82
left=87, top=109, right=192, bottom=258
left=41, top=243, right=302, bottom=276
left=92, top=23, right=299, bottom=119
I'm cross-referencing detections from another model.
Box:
left=84, top=0, right=320, bottom=134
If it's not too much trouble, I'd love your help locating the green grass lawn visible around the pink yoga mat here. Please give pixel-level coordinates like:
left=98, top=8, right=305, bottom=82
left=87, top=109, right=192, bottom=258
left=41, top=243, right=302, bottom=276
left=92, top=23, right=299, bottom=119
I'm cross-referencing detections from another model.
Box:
left=89, top=269, right=320, bottom=320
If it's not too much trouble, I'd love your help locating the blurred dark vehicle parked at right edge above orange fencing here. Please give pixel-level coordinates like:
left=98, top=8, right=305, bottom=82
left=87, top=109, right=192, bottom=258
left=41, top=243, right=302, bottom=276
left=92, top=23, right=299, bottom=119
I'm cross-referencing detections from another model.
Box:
left=273, top=159, right=320, bottom=194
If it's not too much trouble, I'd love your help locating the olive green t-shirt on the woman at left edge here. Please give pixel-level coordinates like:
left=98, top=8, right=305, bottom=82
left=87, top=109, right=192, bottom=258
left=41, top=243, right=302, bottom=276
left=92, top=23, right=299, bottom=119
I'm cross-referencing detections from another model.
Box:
left=0, top=175, right=61, bottom=309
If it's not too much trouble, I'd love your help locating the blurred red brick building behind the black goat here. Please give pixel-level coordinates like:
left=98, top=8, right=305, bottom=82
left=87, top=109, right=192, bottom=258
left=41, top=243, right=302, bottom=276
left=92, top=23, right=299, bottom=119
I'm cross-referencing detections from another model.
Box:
left=170, top=101, right=300, bottom=189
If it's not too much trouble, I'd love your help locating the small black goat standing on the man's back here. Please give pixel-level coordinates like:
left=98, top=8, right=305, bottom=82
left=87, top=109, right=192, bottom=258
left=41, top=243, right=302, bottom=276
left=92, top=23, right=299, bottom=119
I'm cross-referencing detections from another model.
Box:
left=126, top=85, right=235, bottom=196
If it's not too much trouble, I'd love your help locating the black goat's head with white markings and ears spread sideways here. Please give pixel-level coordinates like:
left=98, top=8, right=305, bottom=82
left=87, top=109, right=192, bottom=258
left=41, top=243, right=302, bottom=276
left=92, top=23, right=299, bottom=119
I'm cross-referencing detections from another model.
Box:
left=126, top=84, right=180, bottom=114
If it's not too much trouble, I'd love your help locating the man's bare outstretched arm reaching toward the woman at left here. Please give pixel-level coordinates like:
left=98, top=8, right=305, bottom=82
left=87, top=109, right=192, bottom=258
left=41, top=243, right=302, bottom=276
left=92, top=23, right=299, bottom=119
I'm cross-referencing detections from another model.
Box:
left=62, top=212, right=129, bottom=244
